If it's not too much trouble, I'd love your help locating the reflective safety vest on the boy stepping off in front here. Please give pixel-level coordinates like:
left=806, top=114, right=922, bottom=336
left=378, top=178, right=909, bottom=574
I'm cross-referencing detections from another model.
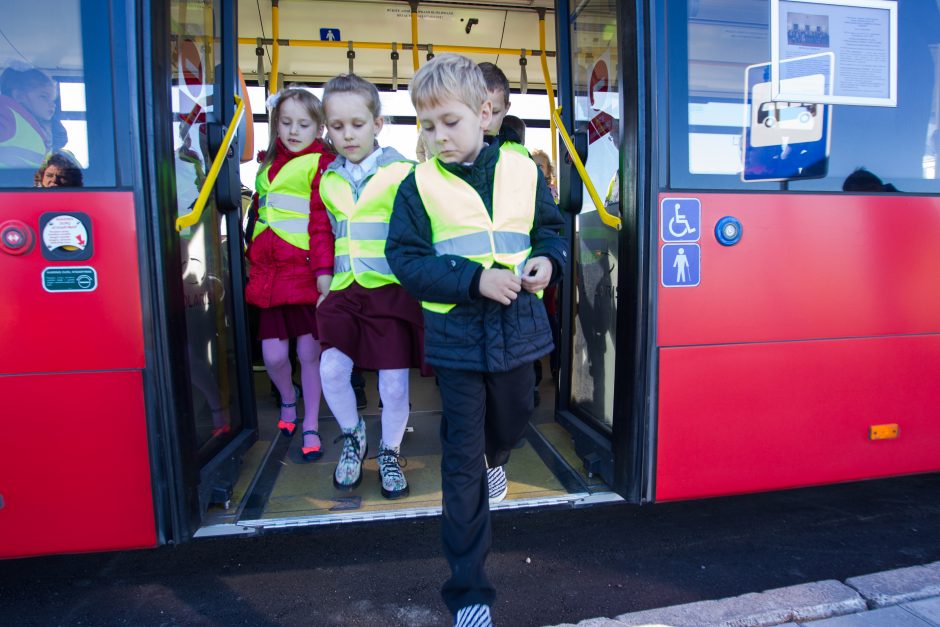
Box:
left=415, top=145, right=538, bottom=313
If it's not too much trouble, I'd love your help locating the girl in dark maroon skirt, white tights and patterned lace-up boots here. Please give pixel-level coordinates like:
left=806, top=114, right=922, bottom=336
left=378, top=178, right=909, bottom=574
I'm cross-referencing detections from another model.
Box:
left=317, top=74, right=424, bottom=499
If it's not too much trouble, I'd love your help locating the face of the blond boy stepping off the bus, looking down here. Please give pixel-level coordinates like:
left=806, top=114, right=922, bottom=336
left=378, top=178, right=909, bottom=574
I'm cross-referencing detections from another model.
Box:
left=418, top=98, right=493, bottom=163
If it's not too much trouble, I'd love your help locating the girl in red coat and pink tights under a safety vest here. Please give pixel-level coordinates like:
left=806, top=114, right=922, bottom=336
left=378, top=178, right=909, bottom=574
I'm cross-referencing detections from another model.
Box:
left=245, top=89, right=333, bottom=461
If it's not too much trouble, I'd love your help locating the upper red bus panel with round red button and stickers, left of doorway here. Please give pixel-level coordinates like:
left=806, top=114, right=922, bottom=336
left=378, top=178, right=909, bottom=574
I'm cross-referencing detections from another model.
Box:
left=0, top=191, right=144, bottom=375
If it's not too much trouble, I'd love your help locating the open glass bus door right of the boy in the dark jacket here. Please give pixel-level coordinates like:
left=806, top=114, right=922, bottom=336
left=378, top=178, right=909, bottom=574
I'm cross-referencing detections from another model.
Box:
left=557, top=0, right=643, bottom=501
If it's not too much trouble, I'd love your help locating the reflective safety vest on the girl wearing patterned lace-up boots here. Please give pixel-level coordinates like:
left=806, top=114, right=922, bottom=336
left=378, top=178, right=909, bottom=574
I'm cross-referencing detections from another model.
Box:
left=320, top=161, right=414, bottom=291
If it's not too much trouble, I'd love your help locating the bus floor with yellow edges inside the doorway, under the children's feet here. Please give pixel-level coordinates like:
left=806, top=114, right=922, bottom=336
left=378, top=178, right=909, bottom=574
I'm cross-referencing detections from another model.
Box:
left=197, top=362, right=609, bottom=535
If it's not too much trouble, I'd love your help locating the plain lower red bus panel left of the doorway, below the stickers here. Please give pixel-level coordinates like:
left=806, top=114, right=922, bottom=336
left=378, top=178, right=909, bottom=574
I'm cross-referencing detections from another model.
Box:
left=0, top=371, right=157, bottom=557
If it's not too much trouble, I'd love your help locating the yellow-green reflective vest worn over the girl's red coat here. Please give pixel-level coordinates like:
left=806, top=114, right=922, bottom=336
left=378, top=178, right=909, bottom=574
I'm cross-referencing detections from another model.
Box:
left=251, top=153, right=320, bottom=250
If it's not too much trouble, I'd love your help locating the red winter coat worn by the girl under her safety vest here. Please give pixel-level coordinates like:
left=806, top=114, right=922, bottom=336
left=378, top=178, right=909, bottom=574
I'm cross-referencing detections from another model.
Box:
left=245, top=139, right=335, bottom=308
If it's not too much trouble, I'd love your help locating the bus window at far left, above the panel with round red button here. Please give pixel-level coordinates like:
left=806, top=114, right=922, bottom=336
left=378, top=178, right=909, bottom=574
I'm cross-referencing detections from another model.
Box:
left=0, top=0, right=115, bottom=188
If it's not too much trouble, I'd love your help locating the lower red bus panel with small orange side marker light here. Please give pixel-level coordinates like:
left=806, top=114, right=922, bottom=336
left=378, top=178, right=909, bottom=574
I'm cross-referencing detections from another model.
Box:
left=656, top=335, right=940, bottom=501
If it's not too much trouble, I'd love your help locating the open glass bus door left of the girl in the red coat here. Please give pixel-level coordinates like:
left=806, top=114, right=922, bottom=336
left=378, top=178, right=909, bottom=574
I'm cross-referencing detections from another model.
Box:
left=153, top=0, right=257, bottom=536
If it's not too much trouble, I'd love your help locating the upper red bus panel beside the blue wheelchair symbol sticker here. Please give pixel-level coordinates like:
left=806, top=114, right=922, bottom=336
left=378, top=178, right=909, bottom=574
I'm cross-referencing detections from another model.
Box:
left=657, top=194, right=940, bottom=346
